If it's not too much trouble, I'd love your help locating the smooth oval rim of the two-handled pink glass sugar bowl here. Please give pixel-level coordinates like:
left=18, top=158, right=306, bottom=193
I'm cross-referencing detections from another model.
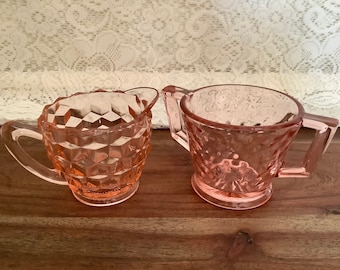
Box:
left=180, top=84, right=305, bottom=132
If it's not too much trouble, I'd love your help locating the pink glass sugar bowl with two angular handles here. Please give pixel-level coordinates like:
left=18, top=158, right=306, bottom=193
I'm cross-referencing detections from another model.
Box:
left=162, top=85, right=338, bottom=210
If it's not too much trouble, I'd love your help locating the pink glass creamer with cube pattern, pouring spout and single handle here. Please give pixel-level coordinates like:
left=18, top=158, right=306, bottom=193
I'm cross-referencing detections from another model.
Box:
left=1, top=88, right=158, bottom=206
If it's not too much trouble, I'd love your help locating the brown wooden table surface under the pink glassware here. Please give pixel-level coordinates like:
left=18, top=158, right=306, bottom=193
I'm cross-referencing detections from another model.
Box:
left=0, top=130, right=340, bottom=270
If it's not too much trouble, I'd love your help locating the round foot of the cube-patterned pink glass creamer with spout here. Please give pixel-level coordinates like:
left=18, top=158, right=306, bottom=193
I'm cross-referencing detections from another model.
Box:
left=72, top=181, right=139, bottom=207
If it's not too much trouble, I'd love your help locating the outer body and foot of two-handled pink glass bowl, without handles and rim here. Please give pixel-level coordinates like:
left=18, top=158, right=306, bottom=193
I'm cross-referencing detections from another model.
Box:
left=184, top=116, right=300, bottom=209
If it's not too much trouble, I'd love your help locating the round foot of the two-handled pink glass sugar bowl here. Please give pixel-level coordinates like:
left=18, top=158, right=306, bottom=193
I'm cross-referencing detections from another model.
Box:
left=191, top=175, right=273, bottom=210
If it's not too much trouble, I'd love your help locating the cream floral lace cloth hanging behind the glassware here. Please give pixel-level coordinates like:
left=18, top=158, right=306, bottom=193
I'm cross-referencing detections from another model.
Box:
left=0, top=0, right=340, bottom=128
